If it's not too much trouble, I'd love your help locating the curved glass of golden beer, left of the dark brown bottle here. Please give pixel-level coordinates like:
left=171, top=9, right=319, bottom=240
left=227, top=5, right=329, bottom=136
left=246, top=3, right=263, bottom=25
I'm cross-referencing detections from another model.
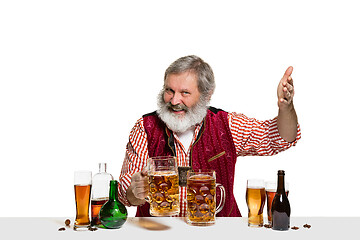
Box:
left=246, top=179, right=265, bottom=227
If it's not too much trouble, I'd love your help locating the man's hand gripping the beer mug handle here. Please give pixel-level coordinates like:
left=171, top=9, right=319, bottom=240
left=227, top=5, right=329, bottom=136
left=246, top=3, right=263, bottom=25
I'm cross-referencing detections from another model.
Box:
left=127, top=170, right=149, bottom=206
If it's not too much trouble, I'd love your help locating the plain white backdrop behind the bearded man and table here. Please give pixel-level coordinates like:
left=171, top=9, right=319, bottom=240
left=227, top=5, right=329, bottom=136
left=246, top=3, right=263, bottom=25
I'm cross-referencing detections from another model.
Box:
left=0, top=0, right=360, bottom=217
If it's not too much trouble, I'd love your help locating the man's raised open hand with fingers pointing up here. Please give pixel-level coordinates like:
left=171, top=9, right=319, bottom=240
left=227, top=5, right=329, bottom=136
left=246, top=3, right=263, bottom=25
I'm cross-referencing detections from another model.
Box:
left=277, top=66, right=295, bottom=109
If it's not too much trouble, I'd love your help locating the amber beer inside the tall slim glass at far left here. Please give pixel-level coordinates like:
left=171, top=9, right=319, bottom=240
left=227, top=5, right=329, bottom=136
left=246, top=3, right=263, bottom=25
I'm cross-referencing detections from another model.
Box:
left=74, top=185, right=91, bottom=226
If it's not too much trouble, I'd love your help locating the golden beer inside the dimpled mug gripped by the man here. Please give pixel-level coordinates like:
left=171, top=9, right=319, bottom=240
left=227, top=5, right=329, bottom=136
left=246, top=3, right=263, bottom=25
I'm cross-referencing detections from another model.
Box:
left=149, top=171, right=180, bottom=216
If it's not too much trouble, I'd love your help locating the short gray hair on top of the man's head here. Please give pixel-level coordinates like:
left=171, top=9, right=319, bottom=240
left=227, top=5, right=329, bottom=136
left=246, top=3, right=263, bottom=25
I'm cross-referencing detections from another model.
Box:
left=164, top=55, right=215, bottom=97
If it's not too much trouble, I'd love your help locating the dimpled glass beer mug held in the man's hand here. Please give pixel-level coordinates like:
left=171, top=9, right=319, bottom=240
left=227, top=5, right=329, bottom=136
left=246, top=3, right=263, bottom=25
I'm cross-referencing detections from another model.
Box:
left=145, top=156, right=180, bottom=216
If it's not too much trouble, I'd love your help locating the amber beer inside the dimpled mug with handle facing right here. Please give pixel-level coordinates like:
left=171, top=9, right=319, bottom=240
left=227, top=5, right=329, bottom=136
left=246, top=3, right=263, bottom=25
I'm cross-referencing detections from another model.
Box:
left=187, top=175, right=216, bottom=225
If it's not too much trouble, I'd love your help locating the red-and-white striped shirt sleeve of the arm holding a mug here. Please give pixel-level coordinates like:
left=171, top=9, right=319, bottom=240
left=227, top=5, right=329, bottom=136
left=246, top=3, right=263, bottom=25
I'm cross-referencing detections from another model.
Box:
left=119, top=118, right=148, bottom=206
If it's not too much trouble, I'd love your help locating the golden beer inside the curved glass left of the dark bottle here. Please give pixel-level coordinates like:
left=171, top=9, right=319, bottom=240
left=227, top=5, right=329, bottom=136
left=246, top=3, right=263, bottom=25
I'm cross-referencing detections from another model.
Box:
left=246, top=188, right=265, bottom=227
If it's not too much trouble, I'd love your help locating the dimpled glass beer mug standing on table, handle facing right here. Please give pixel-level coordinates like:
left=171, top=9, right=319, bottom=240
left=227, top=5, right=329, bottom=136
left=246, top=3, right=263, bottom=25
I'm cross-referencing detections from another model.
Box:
left=186, top=170, right=225, bottom=226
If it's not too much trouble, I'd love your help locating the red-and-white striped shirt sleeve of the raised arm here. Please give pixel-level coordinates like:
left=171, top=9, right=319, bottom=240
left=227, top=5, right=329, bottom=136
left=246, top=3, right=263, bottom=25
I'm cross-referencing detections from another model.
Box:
left=228, top=112, right=301, bottom=156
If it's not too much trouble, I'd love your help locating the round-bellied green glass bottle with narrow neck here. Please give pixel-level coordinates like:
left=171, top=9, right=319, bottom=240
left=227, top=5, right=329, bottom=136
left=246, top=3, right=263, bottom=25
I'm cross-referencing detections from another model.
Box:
left=99, top=180, right=127, bottom=229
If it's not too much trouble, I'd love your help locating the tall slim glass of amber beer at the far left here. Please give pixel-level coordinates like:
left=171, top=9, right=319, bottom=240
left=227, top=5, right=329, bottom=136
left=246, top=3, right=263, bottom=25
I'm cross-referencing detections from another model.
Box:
left=74, top=171, right=92, bottom=231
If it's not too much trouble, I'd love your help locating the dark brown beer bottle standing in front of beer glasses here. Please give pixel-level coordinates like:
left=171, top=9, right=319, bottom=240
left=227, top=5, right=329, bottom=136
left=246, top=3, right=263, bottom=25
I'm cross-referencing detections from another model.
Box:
left=271, top=170, right=290, bottom=231
